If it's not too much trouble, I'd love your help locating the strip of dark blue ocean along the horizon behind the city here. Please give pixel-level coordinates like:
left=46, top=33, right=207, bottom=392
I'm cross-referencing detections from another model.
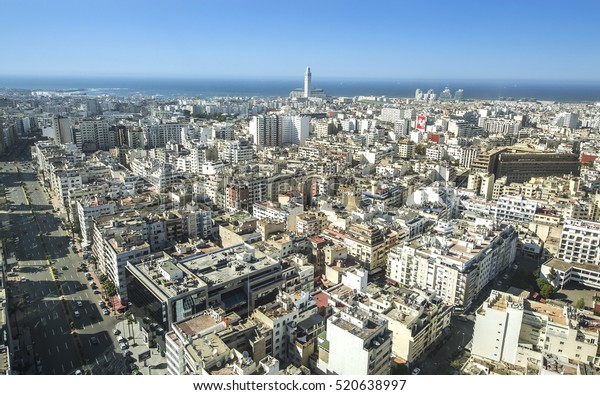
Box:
left=0, top=76, right=600, bottom=102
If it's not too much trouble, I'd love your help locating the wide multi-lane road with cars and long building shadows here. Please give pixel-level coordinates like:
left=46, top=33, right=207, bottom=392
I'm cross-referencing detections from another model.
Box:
left=0, top=138, right=125, bottom=374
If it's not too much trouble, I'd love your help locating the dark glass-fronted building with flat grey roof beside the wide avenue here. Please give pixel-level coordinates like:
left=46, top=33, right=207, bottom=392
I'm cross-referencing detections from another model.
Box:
left=127, top=245, right=283, bottom=329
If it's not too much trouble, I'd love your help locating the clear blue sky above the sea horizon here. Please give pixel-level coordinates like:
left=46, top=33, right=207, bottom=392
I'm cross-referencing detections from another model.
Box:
left=0, top=0, right=600, bottom=81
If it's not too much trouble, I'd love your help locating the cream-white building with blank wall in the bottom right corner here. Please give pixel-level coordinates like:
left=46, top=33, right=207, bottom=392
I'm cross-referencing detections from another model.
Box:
left=471, top=290, right=600, bottom=371
